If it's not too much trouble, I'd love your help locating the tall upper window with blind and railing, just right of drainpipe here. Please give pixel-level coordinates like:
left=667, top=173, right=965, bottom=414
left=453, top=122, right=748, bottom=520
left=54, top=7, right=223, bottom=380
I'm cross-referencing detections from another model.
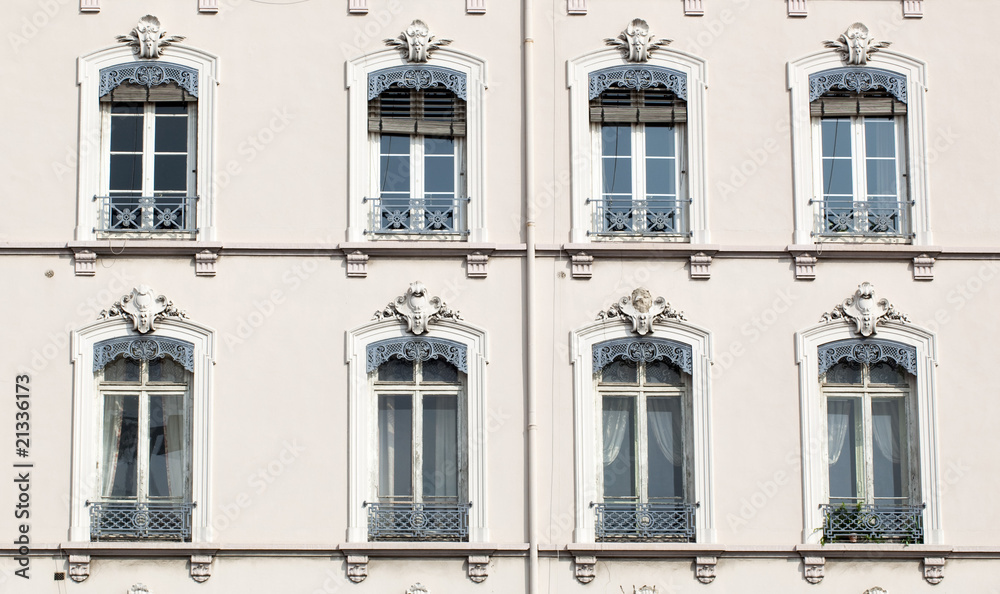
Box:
left=590, top=85, right=689, bottom=237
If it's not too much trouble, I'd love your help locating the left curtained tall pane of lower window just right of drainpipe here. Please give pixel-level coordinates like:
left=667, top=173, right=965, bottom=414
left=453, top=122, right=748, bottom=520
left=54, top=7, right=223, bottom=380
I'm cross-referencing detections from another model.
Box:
left=602, top=396, right=636, bottom=500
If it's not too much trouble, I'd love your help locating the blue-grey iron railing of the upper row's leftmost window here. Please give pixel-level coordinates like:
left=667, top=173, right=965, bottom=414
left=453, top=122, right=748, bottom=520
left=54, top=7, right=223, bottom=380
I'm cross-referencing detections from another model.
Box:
left=94, top=196, right=198, bottom=233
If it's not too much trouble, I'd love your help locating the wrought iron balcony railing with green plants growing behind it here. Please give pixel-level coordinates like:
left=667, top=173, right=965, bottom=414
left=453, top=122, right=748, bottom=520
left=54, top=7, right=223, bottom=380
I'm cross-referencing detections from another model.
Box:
left=820, top=503, right=924, bottom=544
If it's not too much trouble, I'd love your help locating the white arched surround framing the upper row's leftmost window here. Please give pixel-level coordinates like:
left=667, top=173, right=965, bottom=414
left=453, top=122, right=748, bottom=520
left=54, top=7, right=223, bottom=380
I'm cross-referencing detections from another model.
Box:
left=76, top=44, right=219, bottom=241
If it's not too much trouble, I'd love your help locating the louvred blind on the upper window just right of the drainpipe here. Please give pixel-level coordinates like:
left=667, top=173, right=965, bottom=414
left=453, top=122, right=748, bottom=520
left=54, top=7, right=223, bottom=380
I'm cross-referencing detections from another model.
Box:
left=590, top=87, right=687, bottom=124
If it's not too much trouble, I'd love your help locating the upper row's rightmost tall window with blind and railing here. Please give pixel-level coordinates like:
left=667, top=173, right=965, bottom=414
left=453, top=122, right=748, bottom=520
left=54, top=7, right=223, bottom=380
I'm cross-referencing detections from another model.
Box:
left=810, top=91, right=910, bottom=238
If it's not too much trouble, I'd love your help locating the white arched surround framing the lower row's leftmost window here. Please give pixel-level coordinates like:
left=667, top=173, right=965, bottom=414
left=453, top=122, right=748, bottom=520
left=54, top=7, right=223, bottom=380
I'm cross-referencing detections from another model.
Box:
left=70, top=318, right=215, bottom=543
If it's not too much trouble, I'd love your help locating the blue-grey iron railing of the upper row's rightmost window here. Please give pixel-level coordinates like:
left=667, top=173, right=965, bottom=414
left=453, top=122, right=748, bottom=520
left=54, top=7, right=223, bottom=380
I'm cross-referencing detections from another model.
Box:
left=812, top=199, right=914, bottom=237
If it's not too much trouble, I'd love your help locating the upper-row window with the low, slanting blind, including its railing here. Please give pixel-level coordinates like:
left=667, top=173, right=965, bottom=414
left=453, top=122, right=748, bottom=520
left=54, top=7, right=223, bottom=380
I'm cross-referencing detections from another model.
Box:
left=368, top=85, right=468, bottom=236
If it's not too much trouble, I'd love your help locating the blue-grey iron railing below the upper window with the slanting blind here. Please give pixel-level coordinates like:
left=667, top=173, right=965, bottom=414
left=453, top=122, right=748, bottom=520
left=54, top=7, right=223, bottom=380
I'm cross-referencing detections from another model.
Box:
left=364, top=196, right=470, bottom=235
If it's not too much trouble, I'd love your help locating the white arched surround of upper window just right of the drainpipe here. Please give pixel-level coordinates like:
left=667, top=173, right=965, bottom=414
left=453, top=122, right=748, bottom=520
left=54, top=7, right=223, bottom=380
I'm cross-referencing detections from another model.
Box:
left=566, top=47, right=710, bottom=244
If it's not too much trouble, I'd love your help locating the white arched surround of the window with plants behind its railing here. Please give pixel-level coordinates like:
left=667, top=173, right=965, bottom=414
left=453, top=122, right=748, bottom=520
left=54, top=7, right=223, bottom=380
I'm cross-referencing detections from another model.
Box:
left=795, top=322, right=943, bottom=544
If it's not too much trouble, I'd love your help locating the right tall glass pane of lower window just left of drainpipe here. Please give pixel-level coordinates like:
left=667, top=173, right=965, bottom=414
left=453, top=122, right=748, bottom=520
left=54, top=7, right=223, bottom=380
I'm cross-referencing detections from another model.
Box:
left=423, top=396, right=458, bottom=499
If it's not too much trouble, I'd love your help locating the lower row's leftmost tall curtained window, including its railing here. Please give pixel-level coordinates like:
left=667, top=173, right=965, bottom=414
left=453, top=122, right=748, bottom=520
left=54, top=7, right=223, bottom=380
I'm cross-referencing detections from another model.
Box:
left=91, top=356, right=191, bottom=540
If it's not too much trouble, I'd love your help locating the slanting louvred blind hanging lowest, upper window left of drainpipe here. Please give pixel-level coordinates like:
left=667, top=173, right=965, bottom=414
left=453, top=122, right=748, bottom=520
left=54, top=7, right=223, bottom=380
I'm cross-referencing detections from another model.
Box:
left=368, top=88, right=465, bottom=136
